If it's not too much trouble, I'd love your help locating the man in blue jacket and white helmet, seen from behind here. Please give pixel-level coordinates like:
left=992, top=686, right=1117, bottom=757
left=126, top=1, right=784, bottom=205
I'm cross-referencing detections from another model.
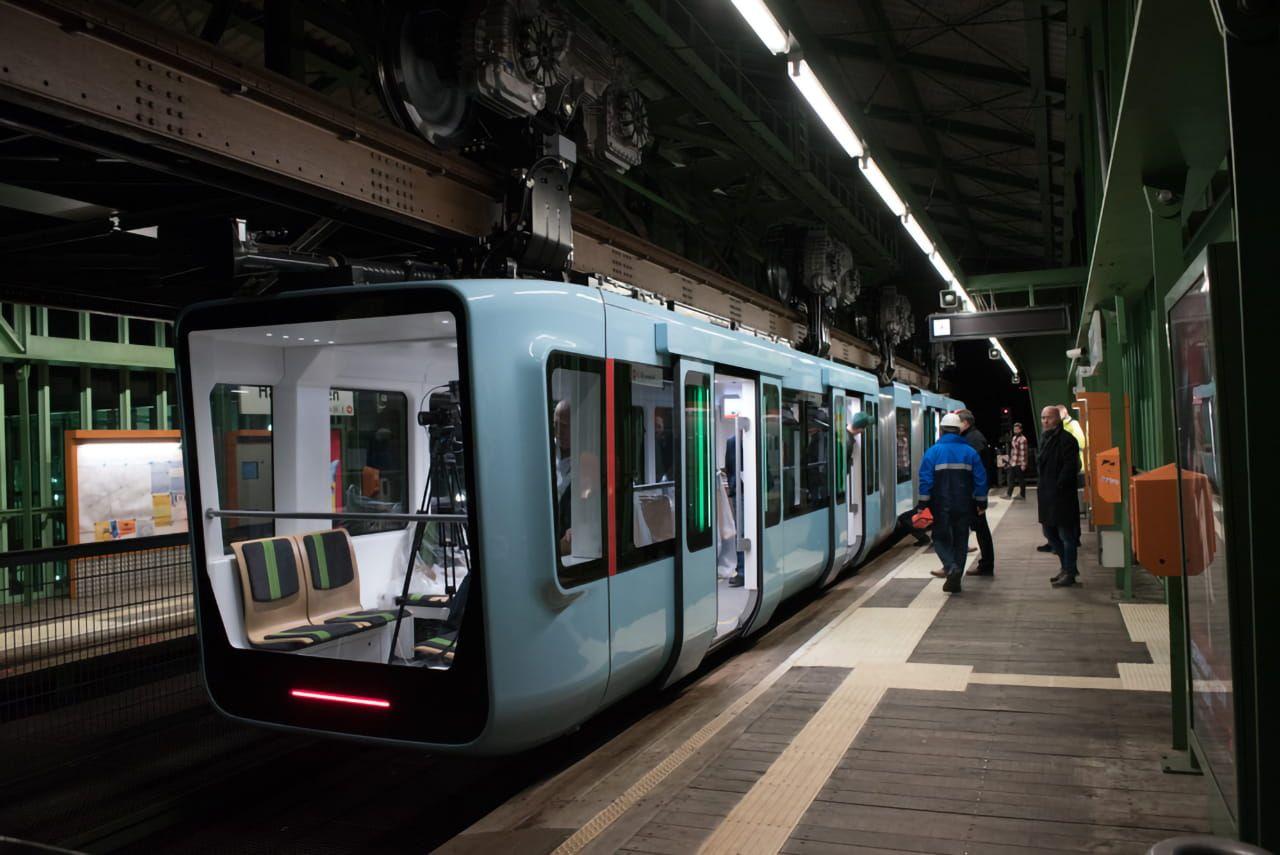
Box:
left=920, top=412, right=987, bottom=594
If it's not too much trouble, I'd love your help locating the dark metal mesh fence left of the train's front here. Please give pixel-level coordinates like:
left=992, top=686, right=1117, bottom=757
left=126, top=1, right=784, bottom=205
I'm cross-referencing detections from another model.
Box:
left=0, top=535, right=202, bottom=759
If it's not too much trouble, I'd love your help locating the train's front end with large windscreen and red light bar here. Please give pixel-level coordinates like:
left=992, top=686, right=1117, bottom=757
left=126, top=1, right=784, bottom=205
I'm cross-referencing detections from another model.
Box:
left=177, top=284, right=489, bottom=749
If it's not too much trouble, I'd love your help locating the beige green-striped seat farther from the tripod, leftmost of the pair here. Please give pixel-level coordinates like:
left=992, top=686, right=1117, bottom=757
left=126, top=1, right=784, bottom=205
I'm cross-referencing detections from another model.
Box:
left=232, top=536, right=361, bottom=650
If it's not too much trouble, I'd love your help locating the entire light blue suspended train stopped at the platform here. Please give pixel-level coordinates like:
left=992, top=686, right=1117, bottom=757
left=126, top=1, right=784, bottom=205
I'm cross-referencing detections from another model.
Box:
left=177, top=279, right=961, bottom=754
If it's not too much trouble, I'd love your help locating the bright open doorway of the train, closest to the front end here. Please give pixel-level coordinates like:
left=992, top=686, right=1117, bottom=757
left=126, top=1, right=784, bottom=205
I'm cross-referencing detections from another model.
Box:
left=712, top=374, right=760, bottom=639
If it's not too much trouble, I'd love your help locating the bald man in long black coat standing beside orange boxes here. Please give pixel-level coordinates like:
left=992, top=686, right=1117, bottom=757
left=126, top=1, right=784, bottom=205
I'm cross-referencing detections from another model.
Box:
left=1036, top=407, right=1080, bottom=587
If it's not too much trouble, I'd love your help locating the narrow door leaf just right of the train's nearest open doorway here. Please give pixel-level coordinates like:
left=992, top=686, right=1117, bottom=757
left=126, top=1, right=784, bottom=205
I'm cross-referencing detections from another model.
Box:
left=742, top=376, right=786, bottom=634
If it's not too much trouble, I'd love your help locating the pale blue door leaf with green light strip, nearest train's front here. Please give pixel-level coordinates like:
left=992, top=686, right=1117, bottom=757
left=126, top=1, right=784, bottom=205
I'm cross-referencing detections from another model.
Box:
left=663, top=358, right=717, bottom=686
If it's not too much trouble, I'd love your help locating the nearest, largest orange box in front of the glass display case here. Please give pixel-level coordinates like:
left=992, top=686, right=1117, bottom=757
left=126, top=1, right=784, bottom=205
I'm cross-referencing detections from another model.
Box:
left=1131, top=463, right=1217, bottom=576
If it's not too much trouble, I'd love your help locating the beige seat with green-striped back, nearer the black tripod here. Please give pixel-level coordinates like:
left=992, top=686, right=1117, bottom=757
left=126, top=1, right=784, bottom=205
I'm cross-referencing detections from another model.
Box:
left=294, top=529, right=396, bottom=630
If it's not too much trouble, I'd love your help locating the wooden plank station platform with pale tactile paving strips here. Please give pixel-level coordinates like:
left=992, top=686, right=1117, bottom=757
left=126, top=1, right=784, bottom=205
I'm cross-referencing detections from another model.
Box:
left=439, top=491, right=1208, bottom=855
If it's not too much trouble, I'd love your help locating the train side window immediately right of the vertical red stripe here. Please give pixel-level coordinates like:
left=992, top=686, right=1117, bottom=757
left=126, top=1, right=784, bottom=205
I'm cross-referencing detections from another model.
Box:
left=613, top=362, right=676, bottom=571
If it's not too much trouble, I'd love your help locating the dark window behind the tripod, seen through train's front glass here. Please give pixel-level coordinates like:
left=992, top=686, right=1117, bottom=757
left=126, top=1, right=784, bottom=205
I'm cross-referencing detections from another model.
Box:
left=329, top=389, right=412, bottom=535
